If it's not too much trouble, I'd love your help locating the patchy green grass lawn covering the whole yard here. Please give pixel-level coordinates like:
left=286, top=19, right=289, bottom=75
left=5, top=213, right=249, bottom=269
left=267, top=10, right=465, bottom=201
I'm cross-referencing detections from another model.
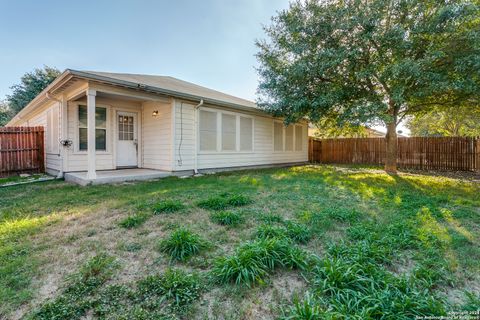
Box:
left=0, top=166, right=480, bottom=319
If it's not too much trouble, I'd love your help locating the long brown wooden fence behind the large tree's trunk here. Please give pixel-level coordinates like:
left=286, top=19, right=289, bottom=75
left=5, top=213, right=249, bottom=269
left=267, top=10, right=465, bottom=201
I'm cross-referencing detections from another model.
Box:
left=308, top=137, right=480, bottom=171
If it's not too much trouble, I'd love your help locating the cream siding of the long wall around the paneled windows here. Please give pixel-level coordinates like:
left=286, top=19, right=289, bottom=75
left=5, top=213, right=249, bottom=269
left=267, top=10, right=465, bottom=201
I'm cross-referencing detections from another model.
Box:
left=174, top=101, right=308, bottom=170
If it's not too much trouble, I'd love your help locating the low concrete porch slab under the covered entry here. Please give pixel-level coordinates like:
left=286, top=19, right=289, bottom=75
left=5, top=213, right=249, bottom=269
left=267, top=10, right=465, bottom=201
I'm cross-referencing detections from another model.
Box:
left=64, top=168, right=172, bottom=186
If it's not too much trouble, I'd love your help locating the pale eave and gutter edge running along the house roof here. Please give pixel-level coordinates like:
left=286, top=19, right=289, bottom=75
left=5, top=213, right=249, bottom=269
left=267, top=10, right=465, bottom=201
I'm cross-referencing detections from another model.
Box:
left=7, top=69, right=266, bottom=126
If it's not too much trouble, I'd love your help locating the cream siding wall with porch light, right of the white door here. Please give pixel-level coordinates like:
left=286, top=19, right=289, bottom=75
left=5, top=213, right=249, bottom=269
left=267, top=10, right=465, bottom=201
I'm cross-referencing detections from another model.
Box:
left=143, top=101, right=172, bottom=171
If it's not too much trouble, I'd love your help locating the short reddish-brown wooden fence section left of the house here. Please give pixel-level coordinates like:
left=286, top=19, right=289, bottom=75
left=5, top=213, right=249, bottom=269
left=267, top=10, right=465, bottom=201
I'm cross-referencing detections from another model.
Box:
left=0, top=127, right=45, bottom=177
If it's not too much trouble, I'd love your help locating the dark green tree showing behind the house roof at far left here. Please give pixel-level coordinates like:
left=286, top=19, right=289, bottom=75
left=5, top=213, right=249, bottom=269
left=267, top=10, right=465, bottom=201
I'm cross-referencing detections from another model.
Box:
left=6, top=66, right=60, bottom=114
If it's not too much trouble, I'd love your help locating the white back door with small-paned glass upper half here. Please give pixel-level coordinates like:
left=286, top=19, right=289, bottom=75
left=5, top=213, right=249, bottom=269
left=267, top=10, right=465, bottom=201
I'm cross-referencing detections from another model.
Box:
left=116, top=112, right=137, bottom=167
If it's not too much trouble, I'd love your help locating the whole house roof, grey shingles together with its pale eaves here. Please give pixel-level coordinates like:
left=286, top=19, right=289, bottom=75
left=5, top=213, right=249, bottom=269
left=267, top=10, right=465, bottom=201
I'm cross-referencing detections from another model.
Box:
left=7, top=69, right=263, bottom=126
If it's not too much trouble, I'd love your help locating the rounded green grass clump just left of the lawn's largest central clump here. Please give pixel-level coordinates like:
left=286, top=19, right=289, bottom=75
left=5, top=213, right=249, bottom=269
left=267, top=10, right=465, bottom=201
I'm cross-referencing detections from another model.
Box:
left=160, top=228, right=206, bottom=261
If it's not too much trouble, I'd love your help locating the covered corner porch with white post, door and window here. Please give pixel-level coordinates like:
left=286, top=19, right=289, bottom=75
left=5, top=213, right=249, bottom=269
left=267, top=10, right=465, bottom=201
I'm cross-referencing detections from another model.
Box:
left=58, top=79, right=173, bottom=185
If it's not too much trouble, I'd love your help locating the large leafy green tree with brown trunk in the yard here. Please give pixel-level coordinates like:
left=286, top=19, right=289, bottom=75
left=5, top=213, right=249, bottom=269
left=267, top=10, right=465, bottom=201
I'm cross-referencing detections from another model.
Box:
left=257, top=0, right=480, bottom=173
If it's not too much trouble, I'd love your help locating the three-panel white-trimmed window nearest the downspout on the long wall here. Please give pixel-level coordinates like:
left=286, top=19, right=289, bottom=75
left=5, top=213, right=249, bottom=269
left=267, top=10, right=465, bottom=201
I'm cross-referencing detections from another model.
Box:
left=199, top=109, right=253, bottom=152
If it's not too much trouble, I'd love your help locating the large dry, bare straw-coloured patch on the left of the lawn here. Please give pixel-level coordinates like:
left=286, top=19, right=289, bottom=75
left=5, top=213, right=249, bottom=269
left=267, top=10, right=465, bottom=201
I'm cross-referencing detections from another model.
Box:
left=13, top=208, right=164, bottom=319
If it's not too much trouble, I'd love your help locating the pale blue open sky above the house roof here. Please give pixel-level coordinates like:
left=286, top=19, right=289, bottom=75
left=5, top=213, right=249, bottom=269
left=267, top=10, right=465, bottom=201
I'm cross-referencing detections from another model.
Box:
left=0, top=0, right=288, bottom=100
